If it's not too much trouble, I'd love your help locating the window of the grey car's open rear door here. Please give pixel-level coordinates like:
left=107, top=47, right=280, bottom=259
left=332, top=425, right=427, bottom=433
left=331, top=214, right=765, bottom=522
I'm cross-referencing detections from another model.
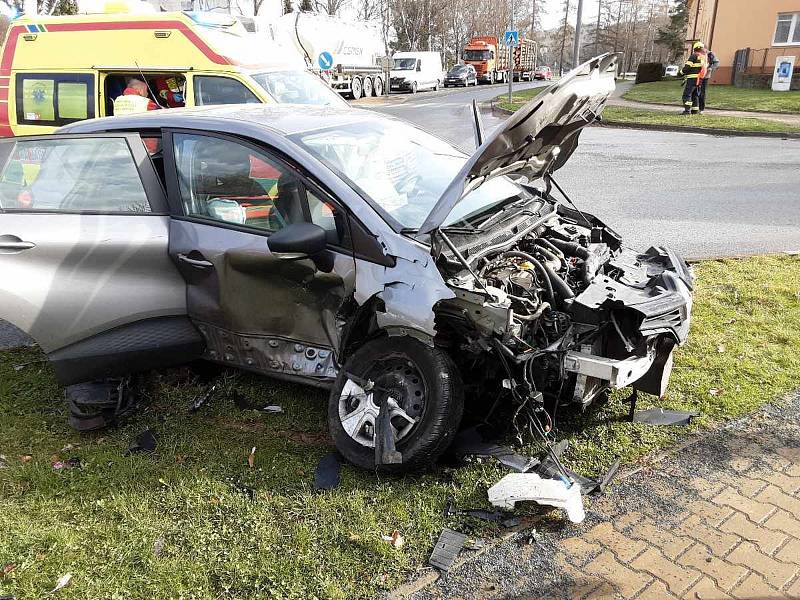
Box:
left=0, top=138, right=150, bottom=213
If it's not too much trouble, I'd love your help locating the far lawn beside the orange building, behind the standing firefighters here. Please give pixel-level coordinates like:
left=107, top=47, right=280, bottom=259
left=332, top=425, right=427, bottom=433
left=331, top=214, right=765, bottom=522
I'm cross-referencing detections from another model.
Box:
left=623, top=80, right=800, bottom=113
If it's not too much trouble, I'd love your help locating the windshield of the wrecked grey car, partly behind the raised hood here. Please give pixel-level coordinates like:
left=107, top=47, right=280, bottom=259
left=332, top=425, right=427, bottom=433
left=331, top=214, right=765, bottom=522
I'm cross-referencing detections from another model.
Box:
left=292, top=121, right=528, bottom=230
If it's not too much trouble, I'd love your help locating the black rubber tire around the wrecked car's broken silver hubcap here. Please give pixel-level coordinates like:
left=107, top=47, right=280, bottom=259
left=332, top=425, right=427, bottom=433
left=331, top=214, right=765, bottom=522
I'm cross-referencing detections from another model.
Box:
left=328, top=337, right=464, bottom=473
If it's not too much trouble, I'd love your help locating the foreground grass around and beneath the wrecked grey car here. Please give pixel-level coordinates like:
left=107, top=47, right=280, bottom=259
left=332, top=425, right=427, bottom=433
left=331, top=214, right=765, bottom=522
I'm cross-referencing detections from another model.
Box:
left=0, top=256, right=800, bottom=598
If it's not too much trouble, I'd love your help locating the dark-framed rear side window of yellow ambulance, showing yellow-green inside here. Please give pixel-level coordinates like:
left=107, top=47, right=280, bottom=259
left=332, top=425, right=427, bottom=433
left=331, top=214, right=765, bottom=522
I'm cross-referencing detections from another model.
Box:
left=16, top=73, right=95, bottom=125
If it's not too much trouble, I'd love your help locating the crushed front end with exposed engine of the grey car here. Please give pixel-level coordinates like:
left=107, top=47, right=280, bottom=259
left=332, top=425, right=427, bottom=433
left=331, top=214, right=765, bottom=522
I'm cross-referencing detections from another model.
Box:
left=434, top=193, right=693, bottom=416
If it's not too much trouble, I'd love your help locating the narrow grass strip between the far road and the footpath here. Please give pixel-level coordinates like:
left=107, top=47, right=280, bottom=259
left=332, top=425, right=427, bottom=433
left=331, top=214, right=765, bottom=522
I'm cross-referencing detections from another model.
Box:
left=603, top=106, right=800, bottom=133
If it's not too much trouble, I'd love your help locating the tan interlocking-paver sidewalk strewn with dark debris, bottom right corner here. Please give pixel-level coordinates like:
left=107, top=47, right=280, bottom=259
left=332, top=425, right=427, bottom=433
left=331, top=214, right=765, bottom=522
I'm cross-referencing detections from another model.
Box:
left=395, top=395, right=800, bottom=600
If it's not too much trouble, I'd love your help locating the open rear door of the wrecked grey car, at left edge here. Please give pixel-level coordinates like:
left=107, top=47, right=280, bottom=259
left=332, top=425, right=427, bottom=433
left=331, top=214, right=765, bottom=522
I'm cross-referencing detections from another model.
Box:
left=0, top=133, right=203, bottom=384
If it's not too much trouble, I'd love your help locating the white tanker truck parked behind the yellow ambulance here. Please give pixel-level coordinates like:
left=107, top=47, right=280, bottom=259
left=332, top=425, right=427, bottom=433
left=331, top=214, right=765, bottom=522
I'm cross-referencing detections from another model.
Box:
left=255, top=12, right=386, bottom=99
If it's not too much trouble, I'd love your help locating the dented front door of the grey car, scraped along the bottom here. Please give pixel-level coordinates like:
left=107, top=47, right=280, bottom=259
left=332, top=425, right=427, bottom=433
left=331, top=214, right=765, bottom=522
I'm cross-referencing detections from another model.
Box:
left=165, top=130, right=355, bottom=384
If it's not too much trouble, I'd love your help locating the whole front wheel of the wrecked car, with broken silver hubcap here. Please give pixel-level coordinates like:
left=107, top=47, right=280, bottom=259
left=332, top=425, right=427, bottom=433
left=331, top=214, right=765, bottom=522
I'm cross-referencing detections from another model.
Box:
left=328, top=337, right=464, bottom=473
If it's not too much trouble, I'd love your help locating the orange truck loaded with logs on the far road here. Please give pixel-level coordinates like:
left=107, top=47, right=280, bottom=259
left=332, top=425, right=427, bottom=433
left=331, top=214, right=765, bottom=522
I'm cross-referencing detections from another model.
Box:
left=461, top=35, right=536, bottom=83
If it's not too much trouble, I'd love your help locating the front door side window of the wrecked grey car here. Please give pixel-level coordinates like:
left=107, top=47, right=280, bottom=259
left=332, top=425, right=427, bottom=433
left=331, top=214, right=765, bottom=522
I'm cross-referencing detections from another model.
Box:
left=173, top=134, right=347, bottom=244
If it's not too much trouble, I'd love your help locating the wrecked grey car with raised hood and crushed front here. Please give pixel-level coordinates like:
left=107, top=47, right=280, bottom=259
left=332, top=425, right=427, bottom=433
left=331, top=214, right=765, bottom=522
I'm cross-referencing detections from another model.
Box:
left=0, top=55, right=693, bottom=471
